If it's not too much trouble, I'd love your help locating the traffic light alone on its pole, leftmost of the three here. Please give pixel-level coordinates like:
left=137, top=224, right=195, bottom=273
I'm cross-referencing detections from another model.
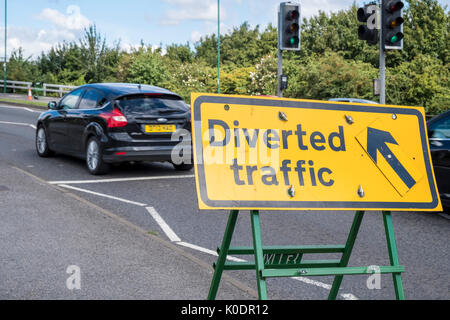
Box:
left=278, top=2, right=300, bottom=51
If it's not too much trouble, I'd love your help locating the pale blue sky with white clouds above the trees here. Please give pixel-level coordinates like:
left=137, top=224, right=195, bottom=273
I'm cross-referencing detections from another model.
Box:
left=0, top=0, right=450, bottom=60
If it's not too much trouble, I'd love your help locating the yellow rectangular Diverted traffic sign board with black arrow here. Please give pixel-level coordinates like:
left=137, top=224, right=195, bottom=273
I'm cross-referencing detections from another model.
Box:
left=191, top=93, right=442, bottom=211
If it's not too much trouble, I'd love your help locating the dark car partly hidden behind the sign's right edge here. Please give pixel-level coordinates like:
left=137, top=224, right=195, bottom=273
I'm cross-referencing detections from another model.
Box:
left=427, top=110, right=450, bottom=212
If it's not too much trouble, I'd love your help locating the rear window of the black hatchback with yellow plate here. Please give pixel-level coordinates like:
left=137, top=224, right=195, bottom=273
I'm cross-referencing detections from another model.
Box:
left=117, top=94, right=188, bottom=115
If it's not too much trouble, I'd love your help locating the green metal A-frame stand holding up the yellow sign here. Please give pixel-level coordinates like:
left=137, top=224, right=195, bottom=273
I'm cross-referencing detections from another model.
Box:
left=208, top=210, right=405, bottom=300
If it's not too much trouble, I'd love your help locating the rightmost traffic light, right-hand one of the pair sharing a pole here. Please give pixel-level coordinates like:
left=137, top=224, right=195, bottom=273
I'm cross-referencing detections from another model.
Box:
left=381, top=0, right=405, bottom=50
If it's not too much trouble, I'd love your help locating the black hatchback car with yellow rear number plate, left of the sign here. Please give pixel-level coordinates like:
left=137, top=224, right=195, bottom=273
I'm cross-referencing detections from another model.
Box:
left=36, top=83, right=193, bottom=175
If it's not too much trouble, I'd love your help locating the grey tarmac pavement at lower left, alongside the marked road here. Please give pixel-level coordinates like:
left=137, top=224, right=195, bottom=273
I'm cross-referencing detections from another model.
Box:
left=0, top=162, right=256, bottom=300
